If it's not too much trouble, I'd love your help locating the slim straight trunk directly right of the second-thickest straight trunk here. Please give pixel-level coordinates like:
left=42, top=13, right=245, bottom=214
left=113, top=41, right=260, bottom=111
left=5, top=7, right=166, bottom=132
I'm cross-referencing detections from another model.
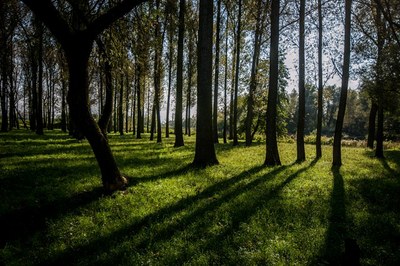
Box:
left=297, top=0, right=306, bottom=163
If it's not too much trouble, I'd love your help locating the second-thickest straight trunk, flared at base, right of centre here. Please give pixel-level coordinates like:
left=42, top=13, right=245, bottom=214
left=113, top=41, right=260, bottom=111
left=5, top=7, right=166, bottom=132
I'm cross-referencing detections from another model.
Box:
left=264, top=0, right=281, bottom=166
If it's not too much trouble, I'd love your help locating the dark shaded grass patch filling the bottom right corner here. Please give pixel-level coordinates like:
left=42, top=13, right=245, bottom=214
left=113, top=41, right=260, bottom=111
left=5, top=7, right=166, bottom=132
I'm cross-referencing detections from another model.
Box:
left=350, top=174, right=400, bottom=265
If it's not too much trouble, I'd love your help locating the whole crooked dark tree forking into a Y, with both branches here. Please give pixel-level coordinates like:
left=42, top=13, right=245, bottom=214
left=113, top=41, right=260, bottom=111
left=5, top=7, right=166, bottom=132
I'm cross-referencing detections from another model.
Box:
left=23, top=0, right=144, bottom=191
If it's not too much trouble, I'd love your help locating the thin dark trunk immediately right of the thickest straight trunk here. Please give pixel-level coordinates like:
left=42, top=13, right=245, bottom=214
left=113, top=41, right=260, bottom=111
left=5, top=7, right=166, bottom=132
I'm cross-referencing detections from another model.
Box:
left=213, top=0, right=221, bottom=143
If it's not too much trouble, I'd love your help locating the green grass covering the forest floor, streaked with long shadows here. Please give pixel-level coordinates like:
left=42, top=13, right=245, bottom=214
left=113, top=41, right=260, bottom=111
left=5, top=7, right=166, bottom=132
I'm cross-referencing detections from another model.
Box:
left=0, top=130, right=400, bottom=265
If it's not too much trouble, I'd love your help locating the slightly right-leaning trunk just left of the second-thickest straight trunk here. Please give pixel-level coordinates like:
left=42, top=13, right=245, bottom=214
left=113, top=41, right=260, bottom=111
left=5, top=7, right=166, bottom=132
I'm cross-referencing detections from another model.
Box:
left=246, top=1, right=262, bottom=146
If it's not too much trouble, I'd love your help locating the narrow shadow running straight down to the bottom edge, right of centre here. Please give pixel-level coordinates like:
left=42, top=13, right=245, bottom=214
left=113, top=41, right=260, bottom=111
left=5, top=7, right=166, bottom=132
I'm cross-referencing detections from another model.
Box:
left=316, top=167, right=347, bottom=265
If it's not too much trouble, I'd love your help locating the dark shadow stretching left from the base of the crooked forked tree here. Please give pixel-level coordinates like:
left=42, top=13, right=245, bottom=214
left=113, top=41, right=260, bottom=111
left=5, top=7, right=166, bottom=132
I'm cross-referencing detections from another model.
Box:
left=0, top=188, right=104, bottom=248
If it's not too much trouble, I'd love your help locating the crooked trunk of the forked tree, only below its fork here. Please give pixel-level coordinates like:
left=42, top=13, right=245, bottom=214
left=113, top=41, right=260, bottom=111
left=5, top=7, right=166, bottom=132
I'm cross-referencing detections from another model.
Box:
left=66, top=38, right=127, bottom=191
